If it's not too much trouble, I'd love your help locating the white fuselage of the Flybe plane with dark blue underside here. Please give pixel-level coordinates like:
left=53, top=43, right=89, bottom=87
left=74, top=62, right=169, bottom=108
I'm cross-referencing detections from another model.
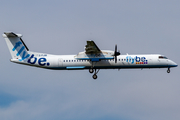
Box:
left=11, top=52, right=177, bottom=70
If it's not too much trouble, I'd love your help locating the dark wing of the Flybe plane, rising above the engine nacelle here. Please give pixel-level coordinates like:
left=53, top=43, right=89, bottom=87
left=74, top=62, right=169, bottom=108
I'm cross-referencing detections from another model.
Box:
left=85, top=40, right=101, bottom=54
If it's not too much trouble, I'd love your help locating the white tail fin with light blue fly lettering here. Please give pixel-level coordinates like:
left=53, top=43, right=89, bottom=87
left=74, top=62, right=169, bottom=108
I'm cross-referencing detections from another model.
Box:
left=3, top=32, right=30, bottom=61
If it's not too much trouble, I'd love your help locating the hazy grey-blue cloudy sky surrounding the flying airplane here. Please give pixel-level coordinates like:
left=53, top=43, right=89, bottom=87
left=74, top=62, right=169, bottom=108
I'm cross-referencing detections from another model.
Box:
left=0, top=0, right=180, bottom=120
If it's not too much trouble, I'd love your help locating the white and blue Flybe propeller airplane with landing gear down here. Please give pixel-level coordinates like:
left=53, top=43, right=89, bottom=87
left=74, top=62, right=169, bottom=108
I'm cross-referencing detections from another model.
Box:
left=3, top=32, right=178, bottom=79
